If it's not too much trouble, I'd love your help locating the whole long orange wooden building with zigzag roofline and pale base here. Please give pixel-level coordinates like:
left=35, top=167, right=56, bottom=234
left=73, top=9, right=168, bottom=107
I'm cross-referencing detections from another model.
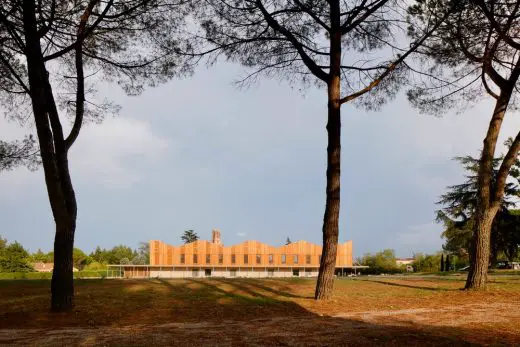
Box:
left=109, top=229, right=363, bottom=278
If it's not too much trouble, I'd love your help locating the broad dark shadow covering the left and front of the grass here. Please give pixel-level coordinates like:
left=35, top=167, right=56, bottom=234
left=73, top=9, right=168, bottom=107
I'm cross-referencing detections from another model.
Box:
left=0, top=279, right=520, bottom=346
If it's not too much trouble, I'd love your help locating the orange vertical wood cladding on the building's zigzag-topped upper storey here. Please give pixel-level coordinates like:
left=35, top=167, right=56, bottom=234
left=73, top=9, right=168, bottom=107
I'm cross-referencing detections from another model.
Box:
left=150, top=240, right=352, bottom=267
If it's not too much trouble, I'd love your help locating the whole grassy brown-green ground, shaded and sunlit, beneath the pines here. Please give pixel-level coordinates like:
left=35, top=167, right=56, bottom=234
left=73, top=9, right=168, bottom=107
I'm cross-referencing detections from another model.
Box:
left=0, top=276, right=520, bottom=346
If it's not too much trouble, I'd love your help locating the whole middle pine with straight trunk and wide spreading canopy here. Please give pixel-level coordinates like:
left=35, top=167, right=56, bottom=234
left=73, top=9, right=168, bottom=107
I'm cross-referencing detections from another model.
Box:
left=187, top=0, right=450, bottom=299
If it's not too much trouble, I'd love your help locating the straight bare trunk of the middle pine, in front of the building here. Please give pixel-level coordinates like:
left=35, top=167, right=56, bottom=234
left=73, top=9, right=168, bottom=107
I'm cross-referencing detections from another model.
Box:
left=314, top=0, right=341, bottom=300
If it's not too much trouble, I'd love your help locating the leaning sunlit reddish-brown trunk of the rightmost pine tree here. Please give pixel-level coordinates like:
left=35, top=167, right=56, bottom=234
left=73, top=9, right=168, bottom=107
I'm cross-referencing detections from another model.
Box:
left=465, top=88, right=512, bottom=289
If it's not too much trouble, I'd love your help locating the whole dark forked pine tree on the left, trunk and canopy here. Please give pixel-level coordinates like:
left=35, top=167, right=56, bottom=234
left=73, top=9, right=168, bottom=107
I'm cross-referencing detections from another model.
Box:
left=0, top=0, right=190, bottom=311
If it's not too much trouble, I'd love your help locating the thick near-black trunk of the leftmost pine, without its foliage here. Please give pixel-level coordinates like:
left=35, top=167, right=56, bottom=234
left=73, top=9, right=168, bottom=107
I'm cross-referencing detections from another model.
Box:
left=23, top=0, right=76, bottom=311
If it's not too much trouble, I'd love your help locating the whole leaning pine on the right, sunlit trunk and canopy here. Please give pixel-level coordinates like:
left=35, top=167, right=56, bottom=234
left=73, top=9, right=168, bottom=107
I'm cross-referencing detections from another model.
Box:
left=409, top=0, right=520, bottom=289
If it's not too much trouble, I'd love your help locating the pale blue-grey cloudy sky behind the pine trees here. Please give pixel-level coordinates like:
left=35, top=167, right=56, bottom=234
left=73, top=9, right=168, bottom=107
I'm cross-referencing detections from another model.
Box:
left=0, top=63, right=520, bottom=257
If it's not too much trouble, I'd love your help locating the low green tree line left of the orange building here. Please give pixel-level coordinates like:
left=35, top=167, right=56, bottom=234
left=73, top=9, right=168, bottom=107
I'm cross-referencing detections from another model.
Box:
left=0, top=237, right=150, bottom=272
